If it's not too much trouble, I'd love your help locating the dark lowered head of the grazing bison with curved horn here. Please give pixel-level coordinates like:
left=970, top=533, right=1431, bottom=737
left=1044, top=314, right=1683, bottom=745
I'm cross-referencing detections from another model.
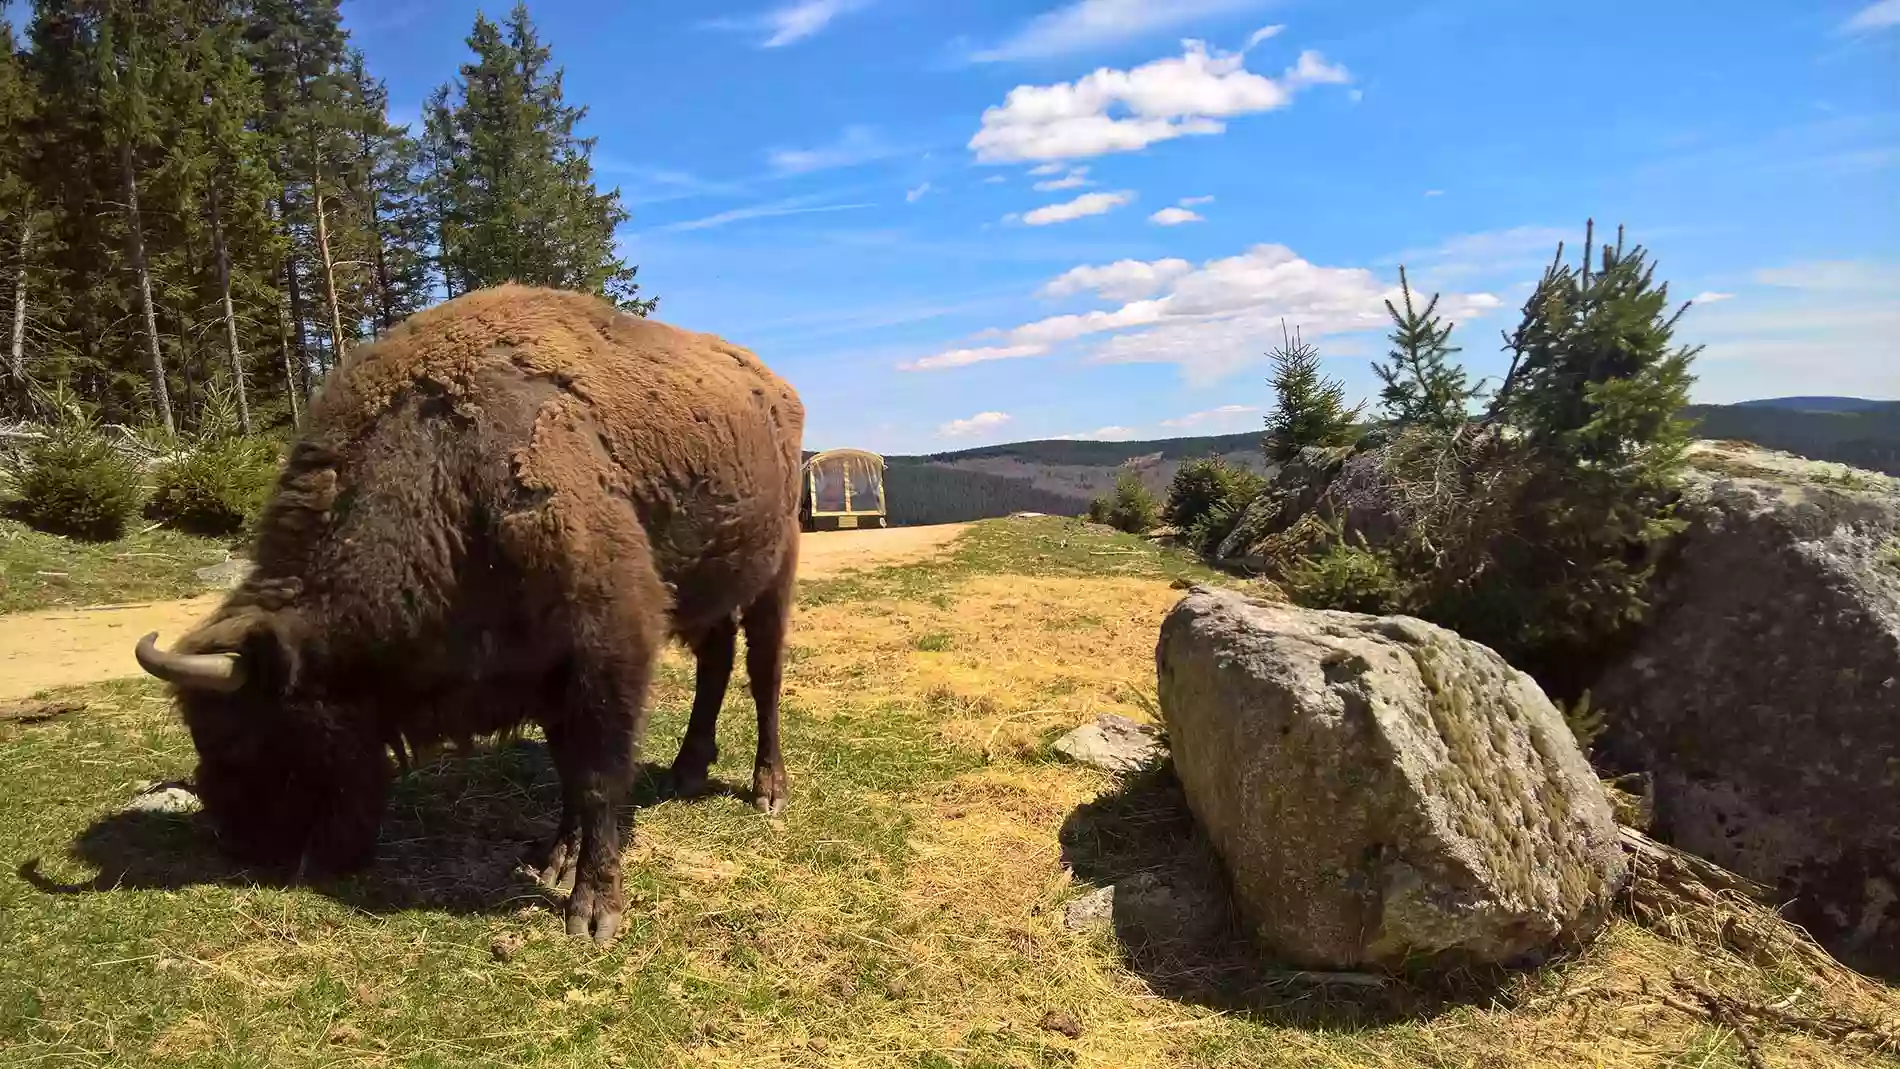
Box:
left=137, top=623, right=390, bottom=872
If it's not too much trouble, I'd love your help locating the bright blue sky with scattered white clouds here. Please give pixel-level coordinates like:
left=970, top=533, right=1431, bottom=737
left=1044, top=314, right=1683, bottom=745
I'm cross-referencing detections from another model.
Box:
left=344, top=0, right=1900, bottom=452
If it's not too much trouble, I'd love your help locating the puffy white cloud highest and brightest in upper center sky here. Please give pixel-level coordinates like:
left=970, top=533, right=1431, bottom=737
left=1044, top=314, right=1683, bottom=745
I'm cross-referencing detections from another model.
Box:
left=969, top=40, right=1347, bottom=163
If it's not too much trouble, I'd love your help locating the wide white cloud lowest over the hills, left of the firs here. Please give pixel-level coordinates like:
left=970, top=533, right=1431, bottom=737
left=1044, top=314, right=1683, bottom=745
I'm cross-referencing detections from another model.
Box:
left=906, top=245, right=1501, bottom=384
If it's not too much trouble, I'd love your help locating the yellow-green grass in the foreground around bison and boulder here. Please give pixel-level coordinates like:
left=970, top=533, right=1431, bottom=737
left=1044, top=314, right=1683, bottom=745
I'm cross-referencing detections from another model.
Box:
left=0, top=520, right=1900, bottom=1069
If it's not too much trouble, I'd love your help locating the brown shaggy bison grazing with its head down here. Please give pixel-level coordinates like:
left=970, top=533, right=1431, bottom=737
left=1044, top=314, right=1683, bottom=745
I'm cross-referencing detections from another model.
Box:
left=137, top=285, right=804, bottom=944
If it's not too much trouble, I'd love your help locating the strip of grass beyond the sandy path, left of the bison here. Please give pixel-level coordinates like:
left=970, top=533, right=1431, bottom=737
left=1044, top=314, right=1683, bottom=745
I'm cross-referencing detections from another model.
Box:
left=0, top=518, right=226, bottom=613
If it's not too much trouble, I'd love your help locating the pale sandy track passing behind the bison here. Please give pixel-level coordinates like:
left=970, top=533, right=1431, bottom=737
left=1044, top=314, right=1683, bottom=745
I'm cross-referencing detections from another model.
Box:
left=0, top=524, right=967, bottom=701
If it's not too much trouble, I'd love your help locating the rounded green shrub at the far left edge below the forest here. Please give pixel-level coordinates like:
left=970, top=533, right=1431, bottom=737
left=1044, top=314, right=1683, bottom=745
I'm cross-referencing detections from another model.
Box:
left=13, top=425, right=139, bottom=541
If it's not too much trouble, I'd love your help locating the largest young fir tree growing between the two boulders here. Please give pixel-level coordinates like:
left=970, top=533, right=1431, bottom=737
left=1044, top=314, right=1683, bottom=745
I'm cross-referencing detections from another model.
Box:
left=1425, top=228, right=1697, bottom=678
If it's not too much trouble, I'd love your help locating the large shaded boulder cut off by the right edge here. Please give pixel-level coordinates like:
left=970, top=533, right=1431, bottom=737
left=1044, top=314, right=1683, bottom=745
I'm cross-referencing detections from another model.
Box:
left=1592, top=442, right=1900, bottom=968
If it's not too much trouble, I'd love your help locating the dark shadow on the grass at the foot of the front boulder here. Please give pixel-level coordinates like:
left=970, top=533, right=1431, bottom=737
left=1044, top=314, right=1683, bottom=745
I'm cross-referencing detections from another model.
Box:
left=1060, top=758, right=1535, bottom=1029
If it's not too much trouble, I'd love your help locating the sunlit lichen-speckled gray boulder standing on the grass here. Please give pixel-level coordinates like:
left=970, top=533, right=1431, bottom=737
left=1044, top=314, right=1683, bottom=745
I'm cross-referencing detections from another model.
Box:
left=1157, top=587, right=1626, bottom=968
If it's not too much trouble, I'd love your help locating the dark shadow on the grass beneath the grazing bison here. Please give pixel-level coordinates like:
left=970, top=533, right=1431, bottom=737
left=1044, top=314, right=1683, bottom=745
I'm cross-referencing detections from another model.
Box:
left=19, top=739, right=751, bottom=913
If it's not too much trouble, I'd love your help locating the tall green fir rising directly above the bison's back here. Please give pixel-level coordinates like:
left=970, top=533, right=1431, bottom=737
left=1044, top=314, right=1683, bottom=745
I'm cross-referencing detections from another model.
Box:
left=426, top=4, right=656, bottom=315
